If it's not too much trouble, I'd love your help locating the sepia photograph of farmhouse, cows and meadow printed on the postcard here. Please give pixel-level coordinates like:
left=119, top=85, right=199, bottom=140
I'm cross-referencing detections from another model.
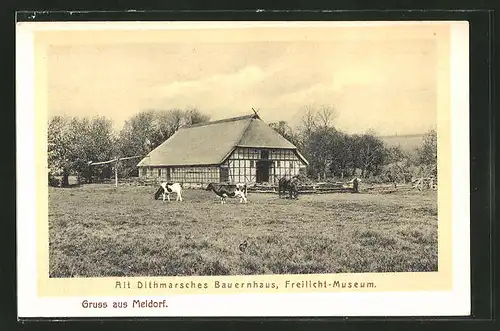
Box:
left=45, top=24, right=445, bottom=278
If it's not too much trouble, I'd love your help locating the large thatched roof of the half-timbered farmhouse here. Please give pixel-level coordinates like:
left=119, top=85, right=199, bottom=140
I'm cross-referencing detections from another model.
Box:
left=137, top=114, right=307, bottom=167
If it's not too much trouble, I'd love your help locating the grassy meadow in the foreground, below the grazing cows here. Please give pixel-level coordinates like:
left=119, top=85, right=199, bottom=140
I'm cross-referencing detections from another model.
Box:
left=49, top=185, right=437, bottom=277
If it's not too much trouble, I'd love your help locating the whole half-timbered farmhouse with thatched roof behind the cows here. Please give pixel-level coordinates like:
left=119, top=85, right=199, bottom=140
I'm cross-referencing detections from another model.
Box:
left=137, top=114, right=308, bottom=186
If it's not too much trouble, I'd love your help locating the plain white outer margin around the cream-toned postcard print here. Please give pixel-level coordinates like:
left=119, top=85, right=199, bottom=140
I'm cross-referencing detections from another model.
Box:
left=16, top=22, right=470, bottom=318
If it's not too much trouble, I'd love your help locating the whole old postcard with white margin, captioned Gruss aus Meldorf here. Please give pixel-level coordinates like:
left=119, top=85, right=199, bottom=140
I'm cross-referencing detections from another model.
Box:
left=16, top=21, right=470, bottom=317
